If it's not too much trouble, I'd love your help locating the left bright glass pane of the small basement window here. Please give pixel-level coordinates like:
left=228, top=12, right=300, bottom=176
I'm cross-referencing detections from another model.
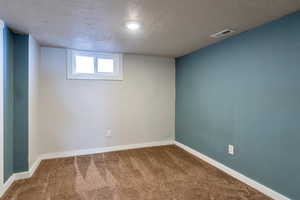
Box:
left=75, top=56, right=94, bottom=74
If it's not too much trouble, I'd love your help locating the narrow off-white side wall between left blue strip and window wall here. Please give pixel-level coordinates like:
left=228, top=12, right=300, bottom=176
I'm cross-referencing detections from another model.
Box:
left=28, top=36, right=40, bottom=168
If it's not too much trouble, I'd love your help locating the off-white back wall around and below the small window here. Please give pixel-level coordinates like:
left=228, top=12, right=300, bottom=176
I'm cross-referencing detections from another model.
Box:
left=38, top=47, right=175, bottom=154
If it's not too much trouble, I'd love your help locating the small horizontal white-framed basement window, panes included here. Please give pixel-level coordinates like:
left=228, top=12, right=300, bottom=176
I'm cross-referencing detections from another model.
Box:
left=67, top=50, right=123, bottom=80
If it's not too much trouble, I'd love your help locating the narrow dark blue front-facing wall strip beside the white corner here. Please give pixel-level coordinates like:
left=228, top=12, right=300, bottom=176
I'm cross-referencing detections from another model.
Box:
left=13, top=33, right=29, bottom=172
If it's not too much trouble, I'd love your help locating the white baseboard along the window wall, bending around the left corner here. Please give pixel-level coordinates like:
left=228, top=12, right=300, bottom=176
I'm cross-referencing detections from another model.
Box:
left=0, top=140, right=174, bottom=198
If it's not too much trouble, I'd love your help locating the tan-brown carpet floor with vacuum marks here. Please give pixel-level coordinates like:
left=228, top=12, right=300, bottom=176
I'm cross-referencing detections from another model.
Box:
left=3, top=145, right=270, bottom=200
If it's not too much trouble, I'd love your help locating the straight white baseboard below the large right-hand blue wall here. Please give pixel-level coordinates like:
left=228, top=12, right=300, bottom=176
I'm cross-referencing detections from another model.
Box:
left=174, top=141, right=290, bottom=200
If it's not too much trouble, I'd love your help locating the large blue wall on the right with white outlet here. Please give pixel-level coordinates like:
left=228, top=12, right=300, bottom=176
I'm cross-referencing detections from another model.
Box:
left=176, top=12, right=300, bottom=199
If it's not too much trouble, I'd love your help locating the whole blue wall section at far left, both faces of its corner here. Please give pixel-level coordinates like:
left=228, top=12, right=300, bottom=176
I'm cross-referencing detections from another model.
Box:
left=3, top=27, right=29, bottom=181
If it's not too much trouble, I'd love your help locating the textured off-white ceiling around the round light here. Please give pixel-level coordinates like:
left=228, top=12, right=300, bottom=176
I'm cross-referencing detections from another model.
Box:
left=0, top=0, right=300, bottom=57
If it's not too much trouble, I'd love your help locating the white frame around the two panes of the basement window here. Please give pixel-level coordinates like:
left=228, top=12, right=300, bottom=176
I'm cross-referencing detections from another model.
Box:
left=67, top=49, right=123, bottom=81
